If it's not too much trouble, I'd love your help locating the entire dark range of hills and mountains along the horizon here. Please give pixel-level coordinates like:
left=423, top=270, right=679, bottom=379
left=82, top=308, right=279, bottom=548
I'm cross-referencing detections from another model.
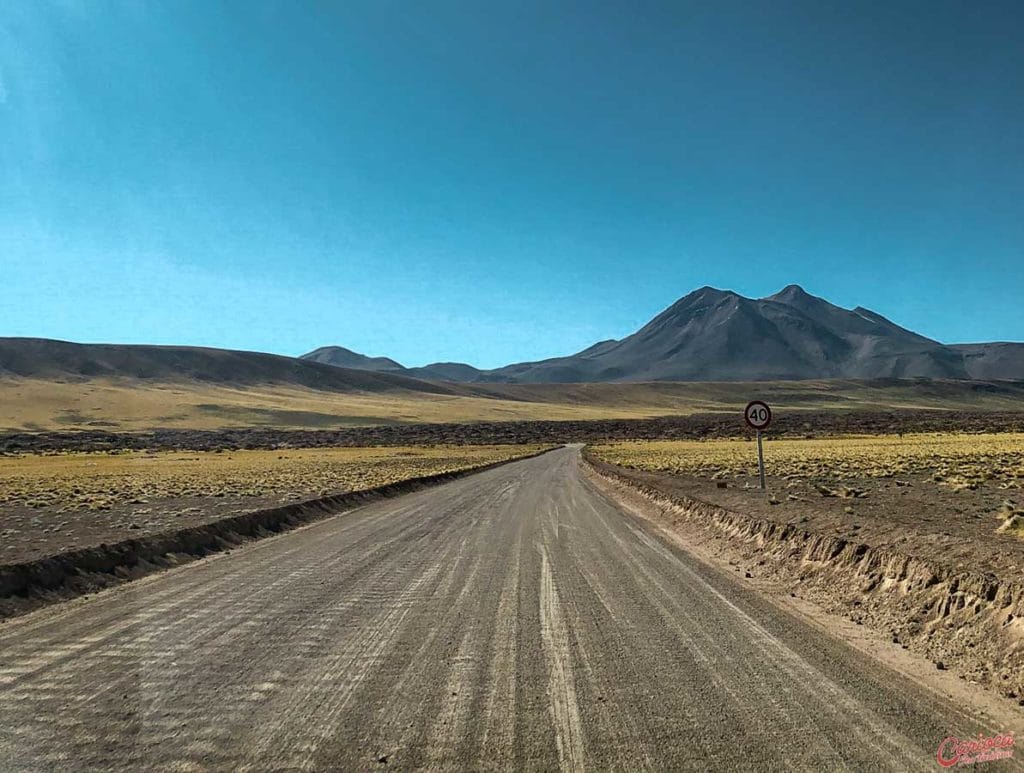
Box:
left=9, top=285, right=1024, bottom=399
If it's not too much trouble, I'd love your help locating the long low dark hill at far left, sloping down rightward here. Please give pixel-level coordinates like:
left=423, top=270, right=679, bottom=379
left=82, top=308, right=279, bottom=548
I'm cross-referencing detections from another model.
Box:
left=0, top=338, right=462, bottom=394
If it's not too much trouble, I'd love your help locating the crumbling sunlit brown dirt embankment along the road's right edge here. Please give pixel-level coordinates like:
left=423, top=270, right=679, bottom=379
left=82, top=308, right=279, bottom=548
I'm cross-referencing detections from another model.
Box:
left=584, top=452, right=1024, bottom=705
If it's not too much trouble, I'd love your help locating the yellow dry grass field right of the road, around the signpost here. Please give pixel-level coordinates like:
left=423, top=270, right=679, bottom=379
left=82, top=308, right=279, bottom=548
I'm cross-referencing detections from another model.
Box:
left=593, top=433, right=1024, bottom=536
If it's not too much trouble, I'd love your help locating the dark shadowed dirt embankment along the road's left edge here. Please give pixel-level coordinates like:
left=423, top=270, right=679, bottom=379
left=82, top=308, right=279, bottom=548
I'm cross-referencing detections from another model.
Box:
left=0, top=448, right=550, bottom=620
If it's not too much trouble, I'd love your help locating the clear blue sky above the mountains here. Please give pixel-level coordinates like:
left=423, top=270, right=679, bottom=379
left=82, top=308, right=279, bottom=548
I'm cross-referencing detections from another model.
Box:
left=0, top=0, right=1024, bottom=367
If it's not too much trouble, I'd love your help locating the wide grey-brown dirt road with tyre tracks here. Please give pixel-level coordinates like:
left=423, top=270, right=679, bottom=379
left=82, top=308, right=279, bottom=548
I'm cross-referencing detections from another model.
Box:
left=0, top=448, right=1022, bottom=770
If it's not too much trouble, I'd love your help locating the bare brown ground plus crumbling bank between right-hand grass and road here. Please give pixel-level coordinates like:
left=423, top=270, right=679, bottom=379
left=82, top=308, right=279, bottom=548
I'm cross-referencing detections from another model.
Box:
left=590, top=457, right=1024, bottom=705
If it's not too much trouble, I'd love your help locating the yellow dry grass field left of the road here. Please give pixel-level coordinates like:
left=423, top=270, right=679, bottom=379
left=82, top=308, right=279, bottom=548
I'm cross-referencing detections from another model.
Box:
left=0, top=445, right=545, bottom=563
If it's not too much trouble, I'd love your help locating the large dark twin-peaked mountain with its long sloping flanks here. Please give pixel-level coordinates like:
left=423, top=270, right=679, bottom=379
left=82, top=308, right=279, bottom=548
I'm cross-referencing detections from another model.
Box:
left=304, top=285, right=1024, bottom=383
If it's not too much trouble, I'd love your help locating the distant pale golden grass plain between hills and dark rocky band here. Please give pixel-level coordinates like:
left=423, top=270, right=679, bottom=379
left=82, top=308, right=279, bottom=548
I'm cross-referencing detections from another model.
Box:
left=0, top=378, right=1024, bottom=431
